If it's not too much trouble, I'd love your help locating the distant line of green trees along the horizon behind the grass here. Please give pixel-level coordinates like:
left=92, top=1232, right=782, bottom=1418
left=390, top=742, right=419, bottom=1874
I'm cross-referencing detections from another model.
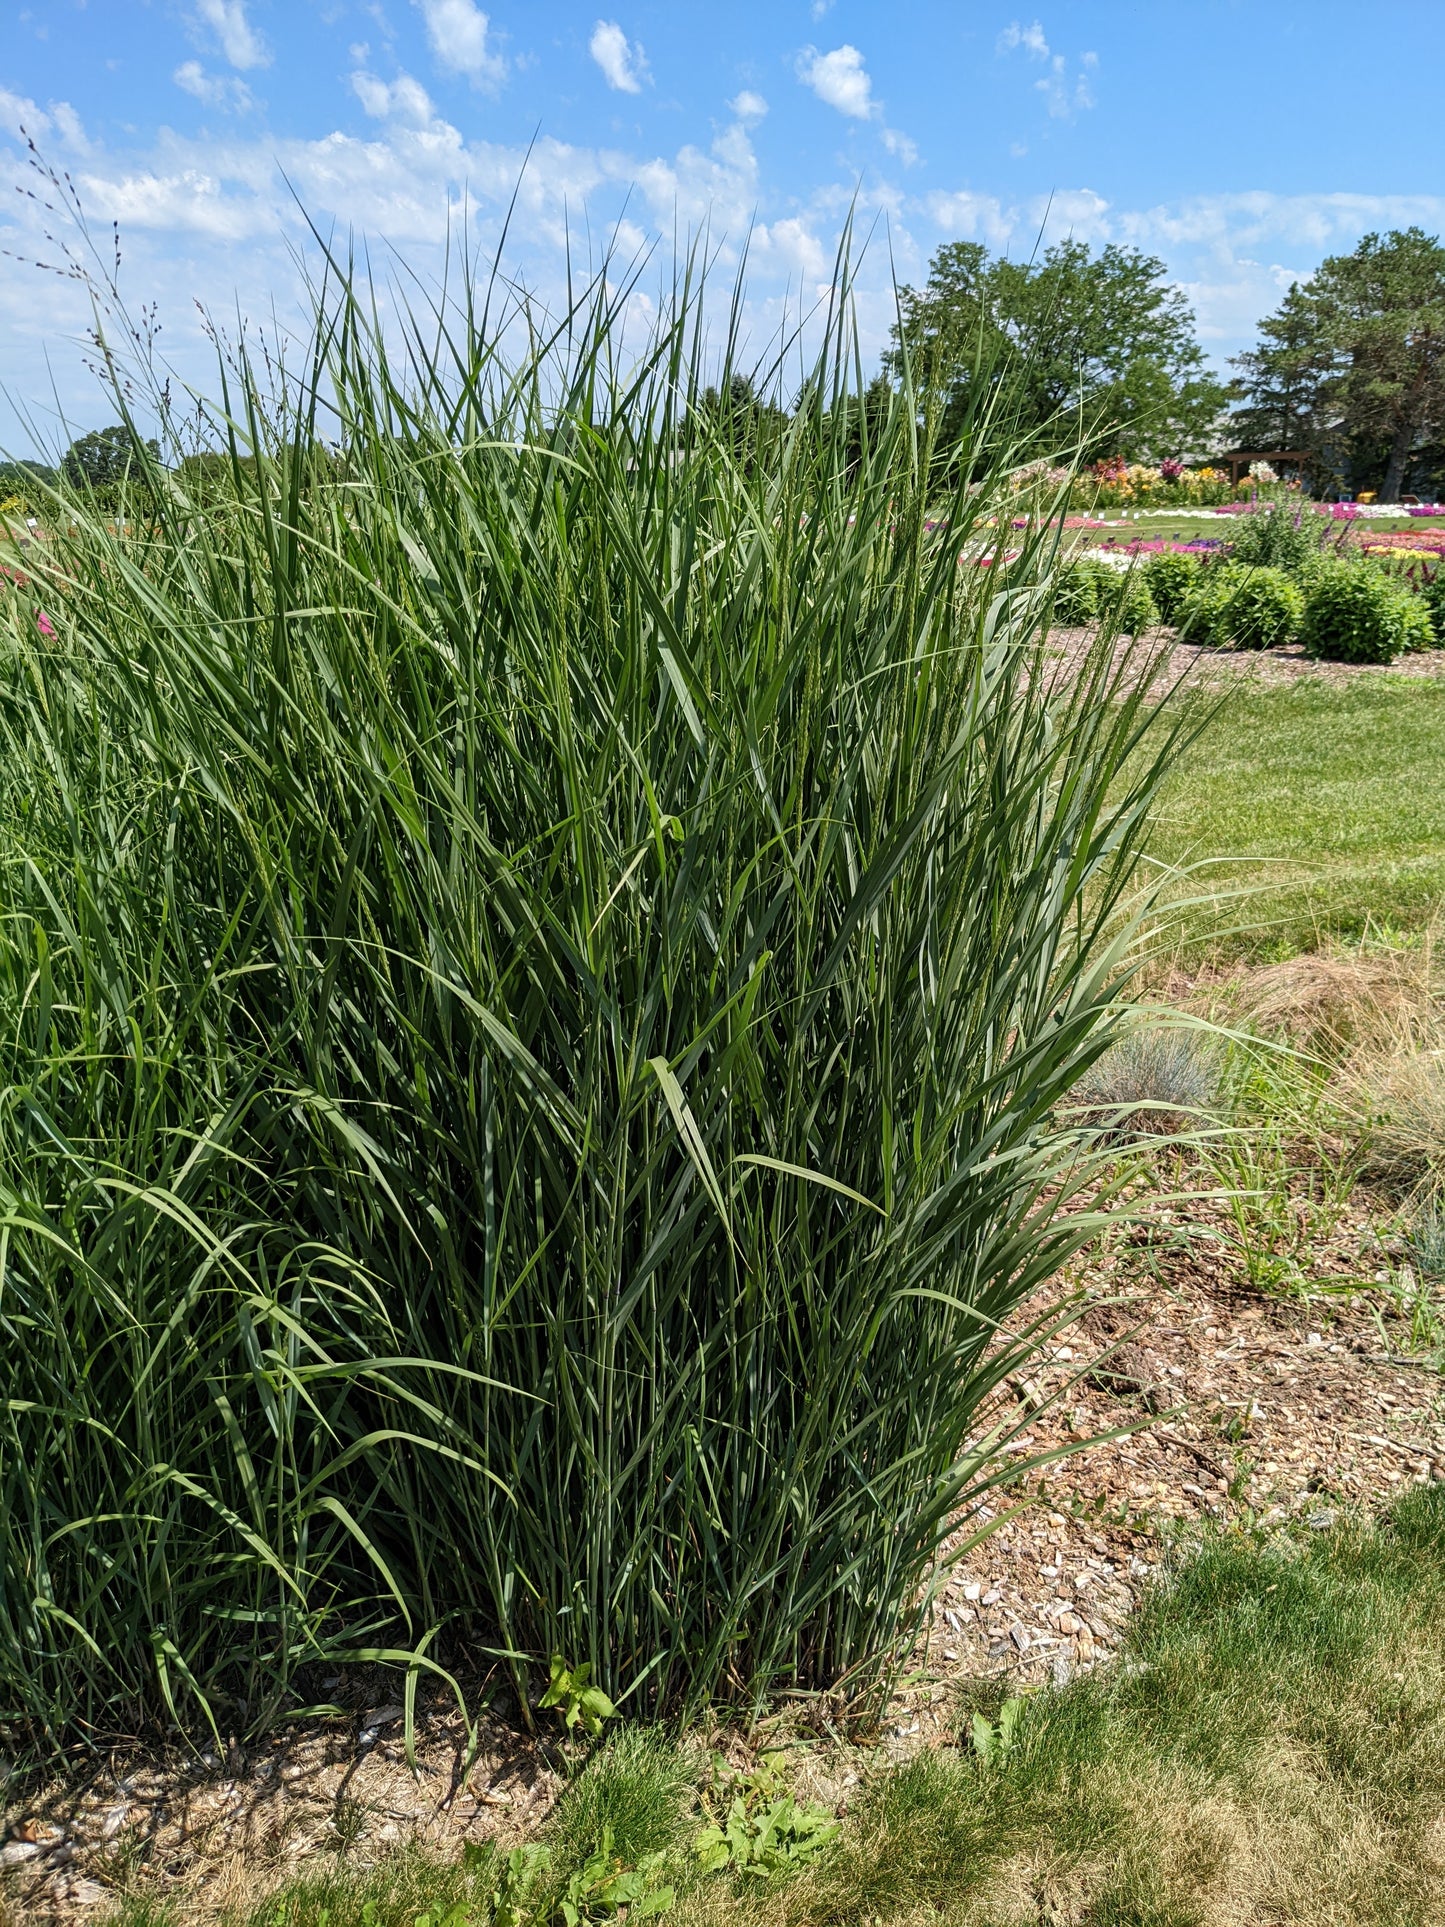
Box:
left=16, top=227, right=1445, bottom=503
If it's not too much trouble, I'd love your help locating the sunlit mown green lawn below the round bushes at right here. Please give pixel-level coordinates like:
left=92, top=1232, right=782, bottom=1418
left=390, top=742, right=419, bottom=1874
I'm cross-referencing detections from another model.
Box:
left=1152, top=674, right=1445, bottom=958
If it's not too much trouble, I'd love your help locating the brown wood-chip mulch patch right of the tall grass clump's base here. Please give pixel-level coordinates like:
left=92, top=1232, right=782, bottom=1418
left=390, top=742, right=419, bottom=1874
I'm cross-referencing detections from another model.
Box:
left=909, top=1195, right=1445, bottom=1734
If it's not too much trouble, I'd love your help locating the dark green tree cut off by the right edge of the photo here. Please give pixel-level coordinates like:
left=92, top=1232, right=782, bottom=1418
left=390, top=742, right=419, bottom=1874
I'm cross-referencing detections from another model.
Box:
left=1235, top=227, right=1445, bottom=501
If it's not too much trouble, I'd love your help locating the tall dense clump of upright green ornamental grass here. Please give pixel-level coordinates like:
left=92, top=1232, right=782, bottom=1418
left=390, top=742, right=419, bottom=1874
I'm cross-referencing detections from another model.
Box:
left=0, top=244, right=1194, bottom=1736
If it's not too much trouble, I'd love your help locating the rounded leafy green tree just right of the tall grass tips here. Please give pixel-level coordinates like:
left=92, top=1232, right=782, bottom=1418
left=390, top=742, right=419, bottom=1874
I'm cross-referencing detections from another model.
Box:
left=886, top=241, right=1227, bottom=459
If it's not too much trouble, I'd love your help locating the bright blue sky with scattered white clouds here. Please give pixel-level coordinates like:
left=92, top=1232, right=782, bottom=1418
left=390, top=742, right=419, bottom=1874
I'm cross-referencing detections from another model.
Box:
left=0, top=0, right=1445, bottom=449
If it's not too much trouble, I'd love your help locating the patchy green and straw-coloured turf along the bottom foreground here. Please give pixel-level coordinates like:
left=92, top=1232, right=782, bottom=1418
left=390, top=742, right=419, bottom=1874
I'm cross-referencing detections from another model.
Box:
left=78, top=1488, right=1445, bottom=1927
